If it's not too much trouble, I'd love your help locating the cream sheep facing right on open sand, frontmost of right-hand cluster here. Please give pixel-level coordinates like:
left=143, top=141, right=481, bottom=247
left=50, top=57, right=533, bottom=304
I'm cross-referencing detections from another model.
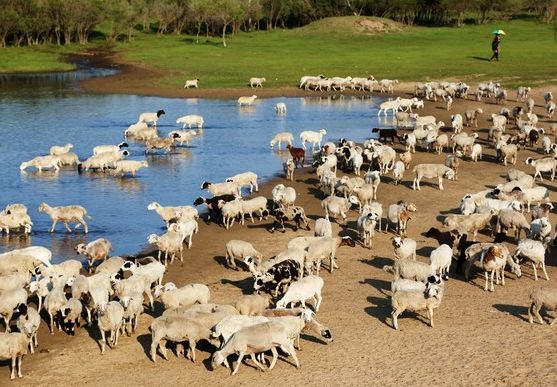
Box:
left=391, top=283, right=444, bottom=330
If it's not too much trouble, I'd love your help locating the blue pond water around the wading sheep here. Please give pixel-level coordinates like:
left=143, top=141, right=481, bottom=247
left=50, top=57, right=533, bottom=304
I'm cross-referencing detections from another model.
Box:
left=0, top=71, right=384, bottom=261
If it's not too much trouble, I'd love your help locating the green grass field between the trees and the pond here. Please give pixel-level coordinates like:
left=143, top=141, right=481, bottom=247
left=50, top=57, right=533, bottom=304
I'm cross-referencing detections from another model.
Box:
left=0, top=17, right=557, bottom=88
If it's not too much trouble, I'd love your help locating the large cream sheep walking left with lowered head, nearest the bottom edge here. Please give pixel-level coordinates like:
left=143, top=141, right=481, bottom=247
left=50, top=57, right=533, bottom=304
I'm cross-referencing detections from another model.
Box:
left=211, top=322, right=300, bottom=375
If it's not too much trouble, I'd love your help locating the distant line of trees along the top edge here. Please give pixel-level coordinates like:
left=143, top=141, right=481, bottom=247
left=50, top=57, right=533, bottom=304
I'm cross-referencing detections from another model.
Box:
left=0, top=0, right=557, bottom=47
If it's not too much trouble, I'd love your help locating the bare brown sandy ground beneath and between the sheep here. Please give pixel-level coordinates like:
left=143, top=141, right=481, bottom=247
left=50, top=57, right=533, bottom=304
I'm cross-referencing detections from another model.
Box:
left=0, top=57, right=557, bottom=386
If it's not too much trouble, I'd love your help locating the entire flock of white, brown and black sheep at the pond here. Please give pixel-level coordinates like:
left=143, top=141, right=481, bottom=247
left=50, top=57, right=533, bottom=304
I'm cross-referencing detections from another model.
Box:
left=0, top=76, right=557, bottom=379
